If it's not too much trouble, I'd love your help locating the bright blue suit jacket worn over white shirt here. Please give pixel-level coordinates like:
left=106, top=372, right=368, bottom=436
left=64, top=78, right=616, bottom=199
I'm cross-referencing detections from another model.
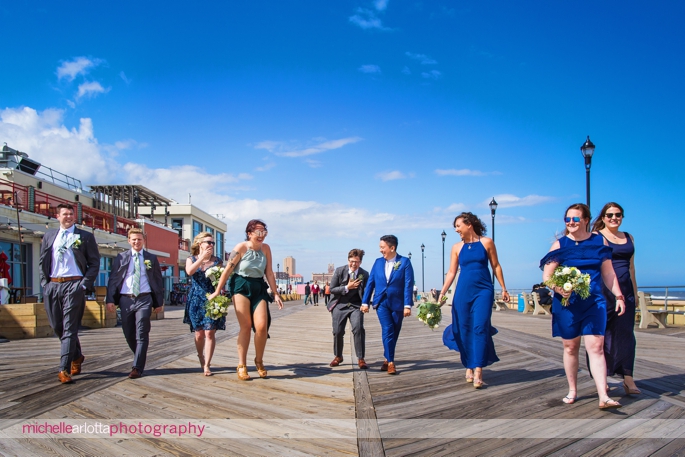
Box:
left=362, top=254, right=414, bottom=311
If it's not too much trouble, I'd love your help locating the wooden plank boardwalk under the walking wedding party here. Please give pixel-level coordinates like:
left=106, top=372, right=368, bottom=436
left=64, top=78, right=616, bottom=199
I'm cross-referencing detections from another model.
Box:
left=0, top=302, right=685, bottom=456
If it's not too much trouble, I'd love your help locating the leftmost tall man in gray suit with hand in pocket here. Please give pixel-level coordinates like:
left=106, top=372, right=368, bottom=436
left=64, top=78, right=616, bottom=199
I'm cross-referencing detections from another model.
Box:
left=39, top=203, right=100, bottom=384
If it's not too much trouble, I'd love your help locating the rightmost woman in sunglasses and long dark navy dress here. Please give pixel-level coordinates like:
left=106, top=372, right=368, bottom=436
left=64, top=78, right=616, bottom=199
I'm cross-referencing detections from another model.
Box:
left=592, top=202, right=642, bottom=395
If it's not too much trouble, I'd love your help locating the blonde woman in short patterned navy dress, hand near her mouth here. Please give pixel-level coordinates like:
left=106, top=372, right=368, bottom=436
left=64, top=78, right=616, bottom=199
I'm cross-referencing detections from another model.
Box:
left=183, top=232, right=226, bottom=376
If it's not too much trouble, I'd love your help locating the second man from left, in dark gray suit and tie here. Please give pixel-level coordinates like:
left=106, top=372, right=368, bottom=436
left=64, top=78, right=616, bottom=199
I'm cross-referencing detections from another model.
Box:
left=107, top=228, right=164, bottom=379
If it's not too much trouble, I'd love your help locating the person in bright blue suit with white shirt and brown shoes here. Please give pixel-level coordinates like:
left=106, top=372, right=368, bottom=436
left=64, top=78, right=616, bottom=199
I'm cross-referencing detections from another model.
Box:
left=360, top=235, right=414, bottom=374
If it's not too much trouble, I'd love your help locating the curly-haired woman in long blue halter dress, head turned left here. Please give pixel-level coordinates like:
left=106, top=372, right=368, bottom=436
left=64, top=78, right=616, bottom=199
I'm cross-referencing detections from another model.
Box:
left=439, top=213, right=509, bottom=389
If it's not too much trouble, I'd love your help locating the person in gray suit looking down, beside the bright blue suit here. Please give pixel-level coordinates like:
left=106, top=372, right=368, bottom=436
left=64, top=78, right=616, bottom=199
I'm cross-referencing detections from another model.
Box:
left=328, top=249, right=369, bottom=370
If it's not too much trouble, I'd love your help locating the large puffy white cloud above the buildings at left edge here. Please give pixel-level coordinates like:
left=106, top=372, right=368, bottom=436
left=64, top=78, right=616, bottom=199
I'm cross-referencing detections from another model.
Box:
left=0, top=107, right=116, bottom=184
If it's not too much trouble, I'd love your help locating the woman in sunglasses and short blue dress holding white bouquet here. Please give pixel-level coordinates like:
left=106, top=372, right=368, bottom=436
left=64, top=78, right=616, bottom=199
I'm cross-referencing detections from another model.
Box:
left=540, top=203, right=625, bottom=409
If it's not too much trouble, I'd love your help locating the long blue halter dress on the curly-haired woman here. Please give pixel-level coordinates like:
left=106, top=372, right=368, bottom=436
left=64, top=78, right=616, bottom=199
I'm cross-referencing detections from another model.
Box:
left=442, top=240, right=499, bottom=369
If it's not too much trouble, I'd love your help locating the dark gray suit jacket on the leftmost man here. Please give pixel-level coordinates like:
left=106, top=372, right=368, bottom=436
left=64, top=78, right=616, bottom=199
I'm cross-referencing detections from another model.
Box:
left=39, top=227, right=100, bottom=292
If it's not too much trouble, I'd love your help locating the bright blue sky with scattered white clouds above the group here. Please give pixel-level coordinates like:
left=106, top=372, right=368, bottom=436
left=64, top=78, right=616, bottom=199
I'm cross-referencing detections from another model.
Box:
left=0, top=0, right=685, bottom=289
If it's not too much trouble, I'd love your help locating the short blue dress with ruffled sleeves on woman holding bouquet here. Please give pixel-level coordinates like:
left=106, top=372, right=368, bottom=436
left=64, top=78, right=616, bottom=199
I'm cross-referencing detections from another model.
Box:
left=540, top=233, right=611, bottom=340
